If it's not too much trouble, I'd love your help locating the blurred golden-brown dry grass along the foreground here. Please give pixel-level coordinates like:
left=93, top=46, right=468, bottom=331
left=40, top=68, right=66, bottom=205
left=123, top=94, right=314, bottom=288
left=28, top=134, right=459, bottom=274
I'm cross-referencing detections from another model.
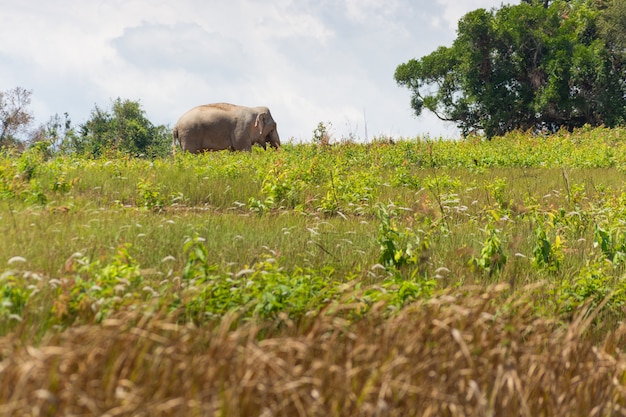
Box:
left=0, top=286, right=626, bottom=416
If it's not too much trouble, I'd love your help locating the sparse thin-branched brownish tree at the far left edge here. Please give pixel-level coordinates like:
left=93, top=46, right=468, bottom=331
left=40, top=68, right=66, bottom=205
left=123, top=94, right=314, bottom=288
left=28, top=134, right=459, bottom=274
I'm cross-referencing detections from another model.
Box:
left=0, top=87, right=33, bottom=146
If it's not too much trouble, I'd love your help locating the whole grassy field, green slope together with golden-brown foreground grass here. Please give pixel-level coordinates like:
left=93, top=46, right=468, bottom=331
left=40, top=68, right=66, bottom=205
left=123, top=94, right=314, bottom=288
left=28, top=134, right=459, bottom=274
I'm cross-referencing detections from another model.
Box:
left=0, top=129, right=626, bottom=416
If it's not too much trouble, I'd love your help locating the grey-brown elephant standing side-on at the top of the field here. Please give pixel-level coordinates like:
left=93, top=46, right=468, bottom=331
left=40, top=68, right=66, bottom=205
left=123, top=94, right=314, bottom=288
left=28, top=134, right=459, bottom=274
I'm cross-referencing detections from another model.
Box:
left=172, top=103, right=280, bottom=153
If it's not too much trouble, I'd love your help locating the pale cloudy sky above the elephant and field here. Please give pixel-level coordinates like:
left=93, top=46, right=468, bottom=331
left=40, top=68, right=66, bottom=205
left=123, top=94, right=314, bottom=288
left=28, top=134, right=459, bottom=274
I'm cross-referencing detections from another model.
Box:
left=0, top=0, right=518, bottom=142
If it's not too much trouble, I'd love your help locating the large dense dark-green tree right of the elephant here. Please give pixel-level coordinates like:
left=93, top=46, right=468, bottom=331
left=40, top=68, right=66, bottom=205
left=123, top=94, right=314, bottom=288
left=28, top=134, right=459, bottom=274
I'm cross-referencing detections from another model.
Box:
left=395, top=0, right=626, bottom=137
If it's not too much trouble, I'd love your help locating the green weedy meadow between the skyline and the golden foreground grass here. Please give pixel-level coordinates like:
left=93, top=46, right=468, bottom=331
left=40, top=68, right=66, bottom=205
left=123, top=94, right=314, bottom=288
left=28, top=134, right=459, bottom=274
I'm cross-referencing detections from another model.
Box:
left=0, top=129, right=626, bottom=415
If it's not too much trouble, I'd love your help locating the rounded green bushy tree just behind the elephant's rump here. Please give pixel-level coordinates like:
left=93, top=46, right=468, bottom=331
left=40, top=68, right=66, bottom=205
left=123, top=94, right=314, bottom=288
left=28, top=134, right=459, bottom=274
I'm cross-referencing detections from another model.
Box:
left=74, top=98, right=171, bottom=157
